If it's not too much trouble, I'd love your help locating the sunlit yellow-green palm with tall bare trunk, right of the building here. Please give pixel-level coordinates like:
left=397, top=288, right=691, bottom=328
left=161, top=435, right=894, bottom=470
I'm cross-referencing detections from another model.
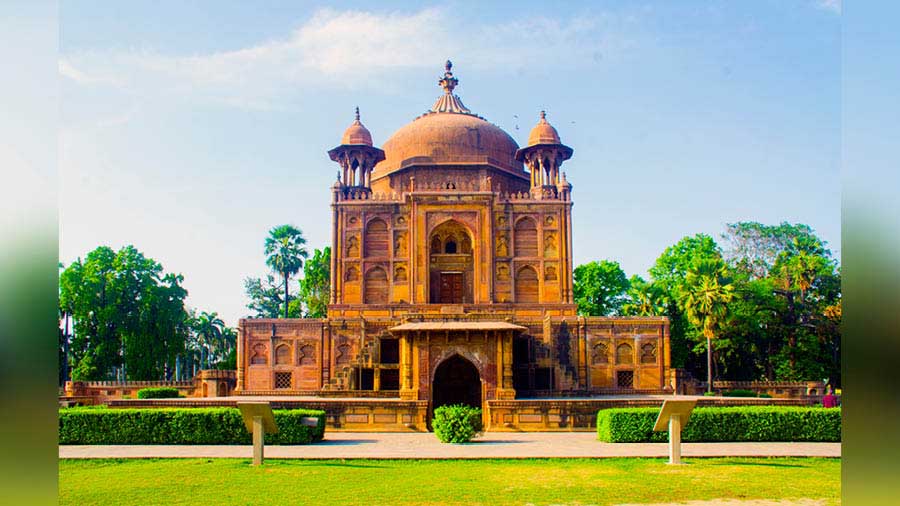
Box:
left=684, top=258, right=734, bottom=392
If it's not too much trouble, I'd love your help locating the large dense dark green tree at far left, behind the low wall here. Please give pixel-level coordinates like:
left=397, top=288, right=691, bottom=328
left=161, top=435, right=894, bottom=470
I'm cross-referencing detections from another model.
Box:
left=59, top=246, right=188, bottom=380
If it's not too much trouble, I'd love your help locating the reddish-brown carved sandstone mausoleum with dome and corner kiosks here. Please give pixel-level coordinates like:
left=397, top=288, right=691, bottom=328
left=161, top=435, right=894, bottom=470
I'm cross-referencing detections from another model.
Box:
left=237, top=62, right=670, bottom=422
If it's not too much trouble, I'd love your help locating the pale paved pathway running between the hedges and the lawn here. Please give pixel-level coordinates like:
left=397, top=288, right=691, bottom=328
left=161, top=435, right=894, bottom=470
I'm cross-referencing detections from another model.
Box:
left=59, top=432, right=841, bottom=459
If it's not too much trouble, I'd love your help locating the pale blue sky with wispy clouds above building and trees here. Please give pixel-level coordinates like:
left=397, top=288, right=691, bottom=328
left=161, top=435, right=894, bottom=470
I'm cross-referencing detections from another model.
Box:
left=59, top=0, right=841, bottom=325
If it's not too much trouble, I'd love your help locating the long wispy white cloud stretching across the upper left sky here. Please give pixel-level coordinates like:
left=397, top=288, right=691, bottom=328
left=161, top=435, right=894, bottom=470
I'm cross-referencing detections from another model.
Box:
left=59, top=8, right=624, bottom=108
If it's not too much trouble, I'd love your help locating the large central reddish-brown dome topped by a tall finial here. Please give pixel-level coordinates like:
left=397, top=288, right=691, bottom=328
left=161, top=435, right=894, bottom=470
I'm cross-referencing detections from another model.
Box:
left=372, top=61, right=528, bottom=178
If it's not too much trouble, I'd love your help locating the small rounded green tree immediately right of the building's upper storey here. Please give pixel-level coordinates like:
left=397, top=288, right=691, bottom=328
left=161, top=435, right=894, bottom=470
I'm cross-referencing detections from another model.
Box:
left=573, top=260, right=629, bottom=316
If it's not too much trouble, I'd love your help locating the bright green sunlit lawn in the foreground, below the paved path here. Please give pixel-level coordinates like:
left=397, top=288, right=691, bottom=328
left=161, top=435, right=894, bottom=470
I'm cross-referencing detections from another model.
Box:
left=59, top=458, right=841, bottom=506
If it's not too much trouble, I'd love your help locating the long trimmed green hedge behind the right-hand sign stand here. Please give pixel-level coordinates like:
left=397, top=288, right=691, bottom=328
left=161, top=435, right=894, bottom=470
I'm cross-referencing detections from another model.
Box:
left=597, top=406, right=841, bottom=443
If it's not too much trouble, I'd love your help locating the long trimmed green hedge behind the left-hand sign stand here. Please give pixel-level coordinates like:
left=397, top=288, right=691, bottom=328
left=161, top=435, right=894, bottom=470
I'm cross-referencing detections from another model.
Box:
left=59, top=408, right=325, bottom=445
